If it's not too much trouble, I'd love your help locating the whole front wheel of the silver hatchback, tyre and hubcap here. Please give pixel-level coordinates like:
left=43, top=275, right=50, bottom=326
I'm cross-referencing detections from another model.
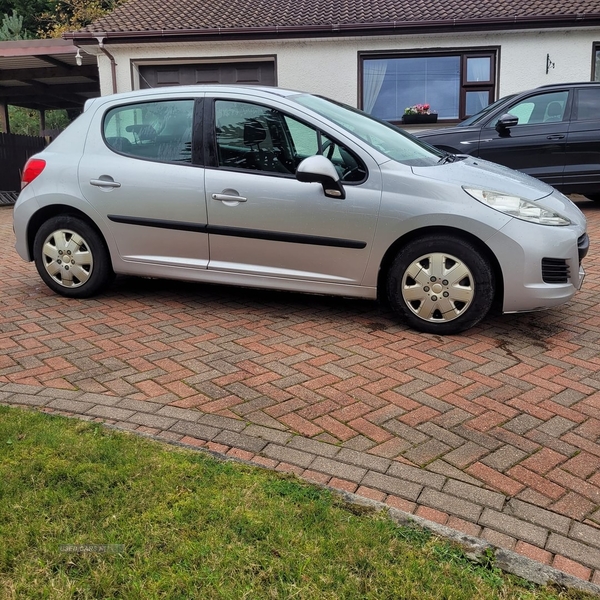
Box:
left=387, top=235, right=495, bottom=335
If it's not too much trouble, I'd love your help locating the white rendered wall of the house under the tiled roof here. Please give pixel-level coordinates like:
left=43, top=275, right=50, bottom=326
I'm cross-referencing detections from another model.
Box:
left=90, top=28, right=600, bottom=106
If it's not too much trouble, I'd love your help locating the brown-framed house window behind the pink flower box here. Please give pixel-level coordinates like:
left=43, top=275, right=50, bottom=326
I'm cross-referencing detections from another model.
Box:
left=360, top=51, right=496, bottom=122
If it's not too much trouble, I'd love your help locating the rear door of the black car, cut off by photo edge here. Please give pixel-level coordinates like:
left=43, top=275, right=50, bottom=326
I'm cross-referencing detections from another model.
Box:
left=564, top=86, right=600, bottom=195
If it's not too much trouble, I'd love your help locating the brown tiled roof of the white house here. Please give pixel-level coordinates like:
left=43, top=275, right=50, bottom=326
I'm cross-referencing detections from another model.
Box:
left=86, top=0, right=600, bottom=33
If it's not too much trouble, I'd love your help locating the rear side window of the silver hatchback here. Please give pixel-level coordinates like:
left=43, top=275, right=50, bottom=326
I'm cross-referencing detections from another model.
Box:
left=103, top=100, right=194, bottom=163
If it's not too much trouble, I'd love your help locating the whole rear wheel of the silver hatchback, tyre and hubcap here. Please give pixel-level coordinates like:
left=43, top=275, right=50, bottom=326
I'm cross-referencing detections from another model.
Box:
left=33, top=215, right=114, bottom=298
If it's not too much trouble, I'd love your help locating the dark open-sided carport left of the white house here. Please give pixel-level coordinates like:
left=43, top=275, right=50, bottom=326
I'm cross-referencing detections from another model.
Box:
left=0, top=39, right=100, bottom=204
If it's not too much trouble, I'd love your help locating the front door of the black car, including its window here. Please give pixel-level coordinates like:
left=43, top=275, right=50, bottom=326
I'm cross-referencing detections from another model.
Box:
left=478, top=90, right=570, bottom=186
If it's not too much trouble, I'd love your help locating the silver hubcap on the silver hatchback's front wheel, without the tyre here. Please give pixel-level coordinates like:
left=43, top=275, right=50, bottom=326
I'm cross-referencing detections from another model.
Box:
left=401, top=252, right=475, bottom=323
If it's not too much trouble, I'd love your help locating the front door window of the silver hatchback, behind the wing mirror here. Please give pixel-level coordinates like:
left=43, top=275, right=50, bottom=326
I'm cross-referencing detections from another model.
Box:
left=215, top=100, right=366, bottom=181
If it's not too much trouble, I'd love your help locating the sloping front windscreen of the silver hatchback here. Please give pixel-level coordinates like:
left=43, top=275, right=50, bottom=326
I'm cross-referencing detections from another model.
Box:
left=293, top=94, right=446, bottom=167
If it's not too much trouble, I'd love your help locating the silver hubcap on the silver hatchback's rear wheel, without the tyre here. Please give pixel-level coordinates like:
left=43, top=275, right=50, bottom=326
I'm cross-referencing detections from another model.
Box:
left=42, top=229, right=94, bottom=288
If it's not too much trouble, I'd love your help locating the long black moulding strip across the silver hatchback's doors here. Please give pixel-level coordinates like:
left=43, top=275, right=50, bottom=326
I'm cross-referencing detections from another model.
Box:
left=108, top=215, right=367, bottom=250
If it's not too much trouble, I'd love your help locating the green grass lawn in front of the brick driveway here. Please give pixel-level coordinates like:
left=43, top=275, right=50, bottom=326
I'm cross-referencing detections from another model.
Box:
left=0, top=406, right=587, bottom=600
